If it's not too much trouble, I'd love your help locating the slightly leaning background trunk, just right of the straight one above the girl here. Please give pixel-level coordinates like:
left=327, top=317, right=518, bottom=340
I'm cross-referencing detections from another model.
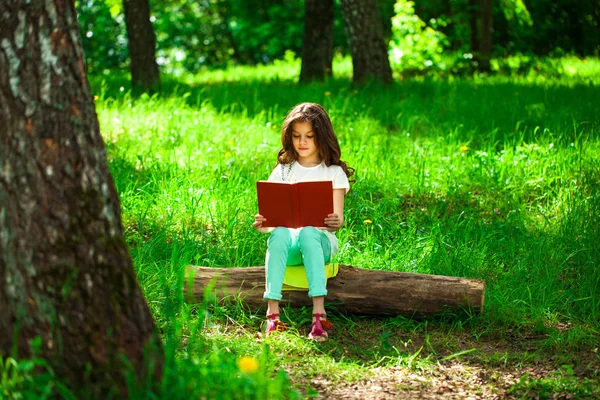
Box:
left=341, top=0, right=392, bottom=83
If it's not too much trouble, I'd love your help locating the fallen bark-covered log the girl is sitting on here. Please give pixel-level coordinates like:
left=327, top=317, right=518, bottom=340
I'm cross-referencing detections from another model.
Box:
left=184, top=265, right=485, bottom=316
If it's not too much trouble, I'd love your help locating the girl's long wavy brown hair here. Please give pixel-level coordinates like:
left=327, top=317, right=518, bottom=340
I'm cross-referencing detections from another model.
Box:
left=277, top=103, right=354, bottom=183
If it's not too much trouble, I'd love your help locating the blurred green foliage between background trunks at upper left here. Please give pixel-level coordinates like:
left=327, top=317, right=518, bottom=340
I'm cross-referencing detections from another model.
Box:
left=77, top=0, right=312, bottom=74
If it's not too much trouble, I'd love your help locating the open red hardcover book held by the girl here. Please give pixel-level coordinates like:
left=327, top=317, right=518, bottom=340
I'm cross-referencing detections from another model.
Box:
left=256, top=181, right=333, bottom=228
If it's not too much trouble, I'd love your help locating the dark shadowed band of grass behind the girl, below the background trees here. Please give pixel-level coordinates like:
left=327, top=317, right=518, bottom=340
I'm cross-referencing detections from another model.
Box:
left=91, top=74, right=600, bottom=147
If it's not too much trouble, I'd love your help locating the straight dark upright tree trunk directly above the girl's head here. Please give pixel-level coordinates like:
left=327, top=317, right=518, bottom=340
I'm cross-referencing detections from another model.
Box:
left=300, top=0, right=333, bottom=82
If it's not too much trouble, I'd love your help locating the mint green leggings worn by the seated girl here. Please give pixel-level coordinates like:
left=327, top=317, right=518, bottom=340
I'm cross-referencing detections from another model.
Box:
left=263, top=226, right=331, bottom=300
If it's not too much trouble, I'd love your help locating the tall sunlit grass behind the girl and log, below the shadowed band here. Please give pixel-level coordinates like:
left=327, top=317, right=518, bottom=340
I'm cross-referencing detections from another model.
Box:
left=99, top=76, right=600, bottom=322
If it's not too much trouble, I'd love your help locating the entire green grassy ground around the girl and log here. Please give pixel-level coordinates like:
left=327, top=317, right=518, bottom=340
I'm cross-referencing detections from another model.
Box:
left=4, top=55, right=600, bottom=398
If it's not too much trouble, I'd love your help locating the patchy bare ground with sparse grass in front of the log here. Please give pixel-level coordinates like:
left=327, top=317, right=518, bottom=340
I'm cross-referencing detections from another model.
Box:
left=216, top=317, right=600, bottom=399
